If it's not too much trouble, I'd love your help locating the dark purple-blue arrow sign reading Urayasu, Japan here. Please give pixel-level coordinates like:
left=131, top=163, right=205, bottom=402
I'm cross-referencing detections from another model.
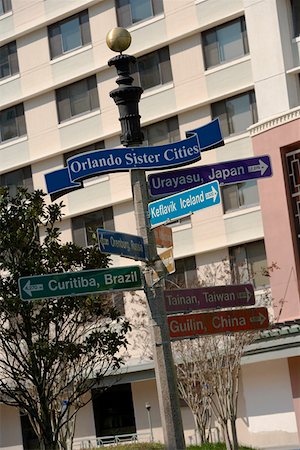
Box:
left=148, top=155, right=272, bottom=197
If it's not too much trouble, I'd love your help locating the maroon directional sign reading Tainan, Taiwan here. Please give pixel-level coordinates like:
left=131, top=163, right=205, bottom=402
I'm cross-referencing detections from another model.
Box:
left=164, top=284, right=255, bottom=314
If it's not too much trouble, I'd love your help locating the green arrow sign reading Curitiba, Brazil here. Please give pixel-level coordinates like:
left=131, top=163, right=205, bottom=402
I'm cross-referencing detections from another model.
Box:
left=18, top=266, right=143, bottom=300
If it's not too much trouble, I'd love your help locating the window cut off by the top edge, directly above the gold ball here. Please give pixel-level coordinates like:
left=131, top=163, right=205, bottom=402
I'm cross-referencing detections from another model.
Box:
left=116, top=0, right=163, bottom=28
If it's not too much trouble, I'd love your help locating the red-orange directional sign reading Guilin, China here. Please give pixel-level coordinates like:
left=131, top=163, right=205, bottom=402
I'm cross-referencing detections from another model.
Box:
left=168, top=307, right=269, bottom=339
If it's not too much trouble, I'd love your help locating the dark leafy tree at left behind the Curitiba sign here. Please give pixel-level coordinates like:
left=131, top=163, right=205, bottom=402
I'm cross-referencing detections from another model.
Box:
left=0, top=188, right=129, bottom=450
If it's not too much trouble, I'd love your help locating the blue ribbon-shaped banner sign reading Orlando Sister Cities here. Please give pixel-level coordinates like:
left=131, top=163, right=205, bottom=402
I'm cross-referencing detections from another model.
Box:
left=45, top=119, right=224, bottom=198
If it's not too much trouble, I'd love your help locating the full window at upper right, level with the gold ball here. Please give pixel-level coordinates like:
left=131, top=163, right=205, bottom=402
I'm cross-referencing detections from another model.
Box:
left=202, top=16, right=249, bottom=70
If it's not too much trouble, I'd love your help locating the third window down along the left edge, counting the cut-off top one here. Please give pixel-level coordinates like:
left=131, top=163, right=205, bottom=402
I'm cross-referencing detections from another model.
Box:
left=0, top=103, right=26, bottom=142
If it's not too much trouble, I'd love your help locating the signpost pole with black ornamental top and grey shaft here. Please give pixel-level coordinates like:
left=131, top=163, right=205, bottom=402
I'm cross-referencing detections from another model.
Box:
left=108, top=54, right=185, bottom=450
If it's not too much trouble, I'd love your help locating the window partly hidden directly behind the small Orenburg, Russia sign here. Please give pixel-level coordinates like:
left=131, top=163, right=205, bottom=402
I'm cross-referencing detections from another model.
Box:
left=72, top=207, right=115, bottom=247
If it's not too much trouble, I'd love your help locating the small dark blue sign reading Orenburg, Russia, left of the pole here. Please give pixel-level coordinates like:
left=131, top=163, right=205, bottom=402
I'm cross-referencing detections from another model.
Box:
left=97, top=228, right=146, bottom=260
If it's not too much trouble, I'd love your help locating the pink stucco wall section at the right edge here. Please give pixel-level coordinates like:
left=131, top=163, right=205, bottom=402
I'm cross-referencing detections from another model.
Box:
left=252, top=120, right=300, bottom=322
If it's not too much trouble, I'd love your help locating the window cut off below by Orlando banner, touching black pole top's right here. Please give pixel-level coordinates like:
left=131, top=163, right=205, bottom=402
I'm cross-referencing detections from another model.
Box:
left=142, top=116, right=180, bottom=145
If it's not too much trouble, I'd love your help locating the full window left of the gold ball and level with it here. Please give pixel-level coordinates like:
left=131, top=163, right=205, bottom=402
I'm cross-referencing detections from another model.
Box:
left=48, top=9, right=92, bottom=60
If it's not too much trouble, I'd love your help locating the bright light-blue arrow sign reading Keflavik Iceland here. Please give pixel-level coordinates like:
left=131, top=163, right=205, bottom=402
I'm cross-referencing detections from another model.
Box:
left=148, top=181, right=221, bottom=226
